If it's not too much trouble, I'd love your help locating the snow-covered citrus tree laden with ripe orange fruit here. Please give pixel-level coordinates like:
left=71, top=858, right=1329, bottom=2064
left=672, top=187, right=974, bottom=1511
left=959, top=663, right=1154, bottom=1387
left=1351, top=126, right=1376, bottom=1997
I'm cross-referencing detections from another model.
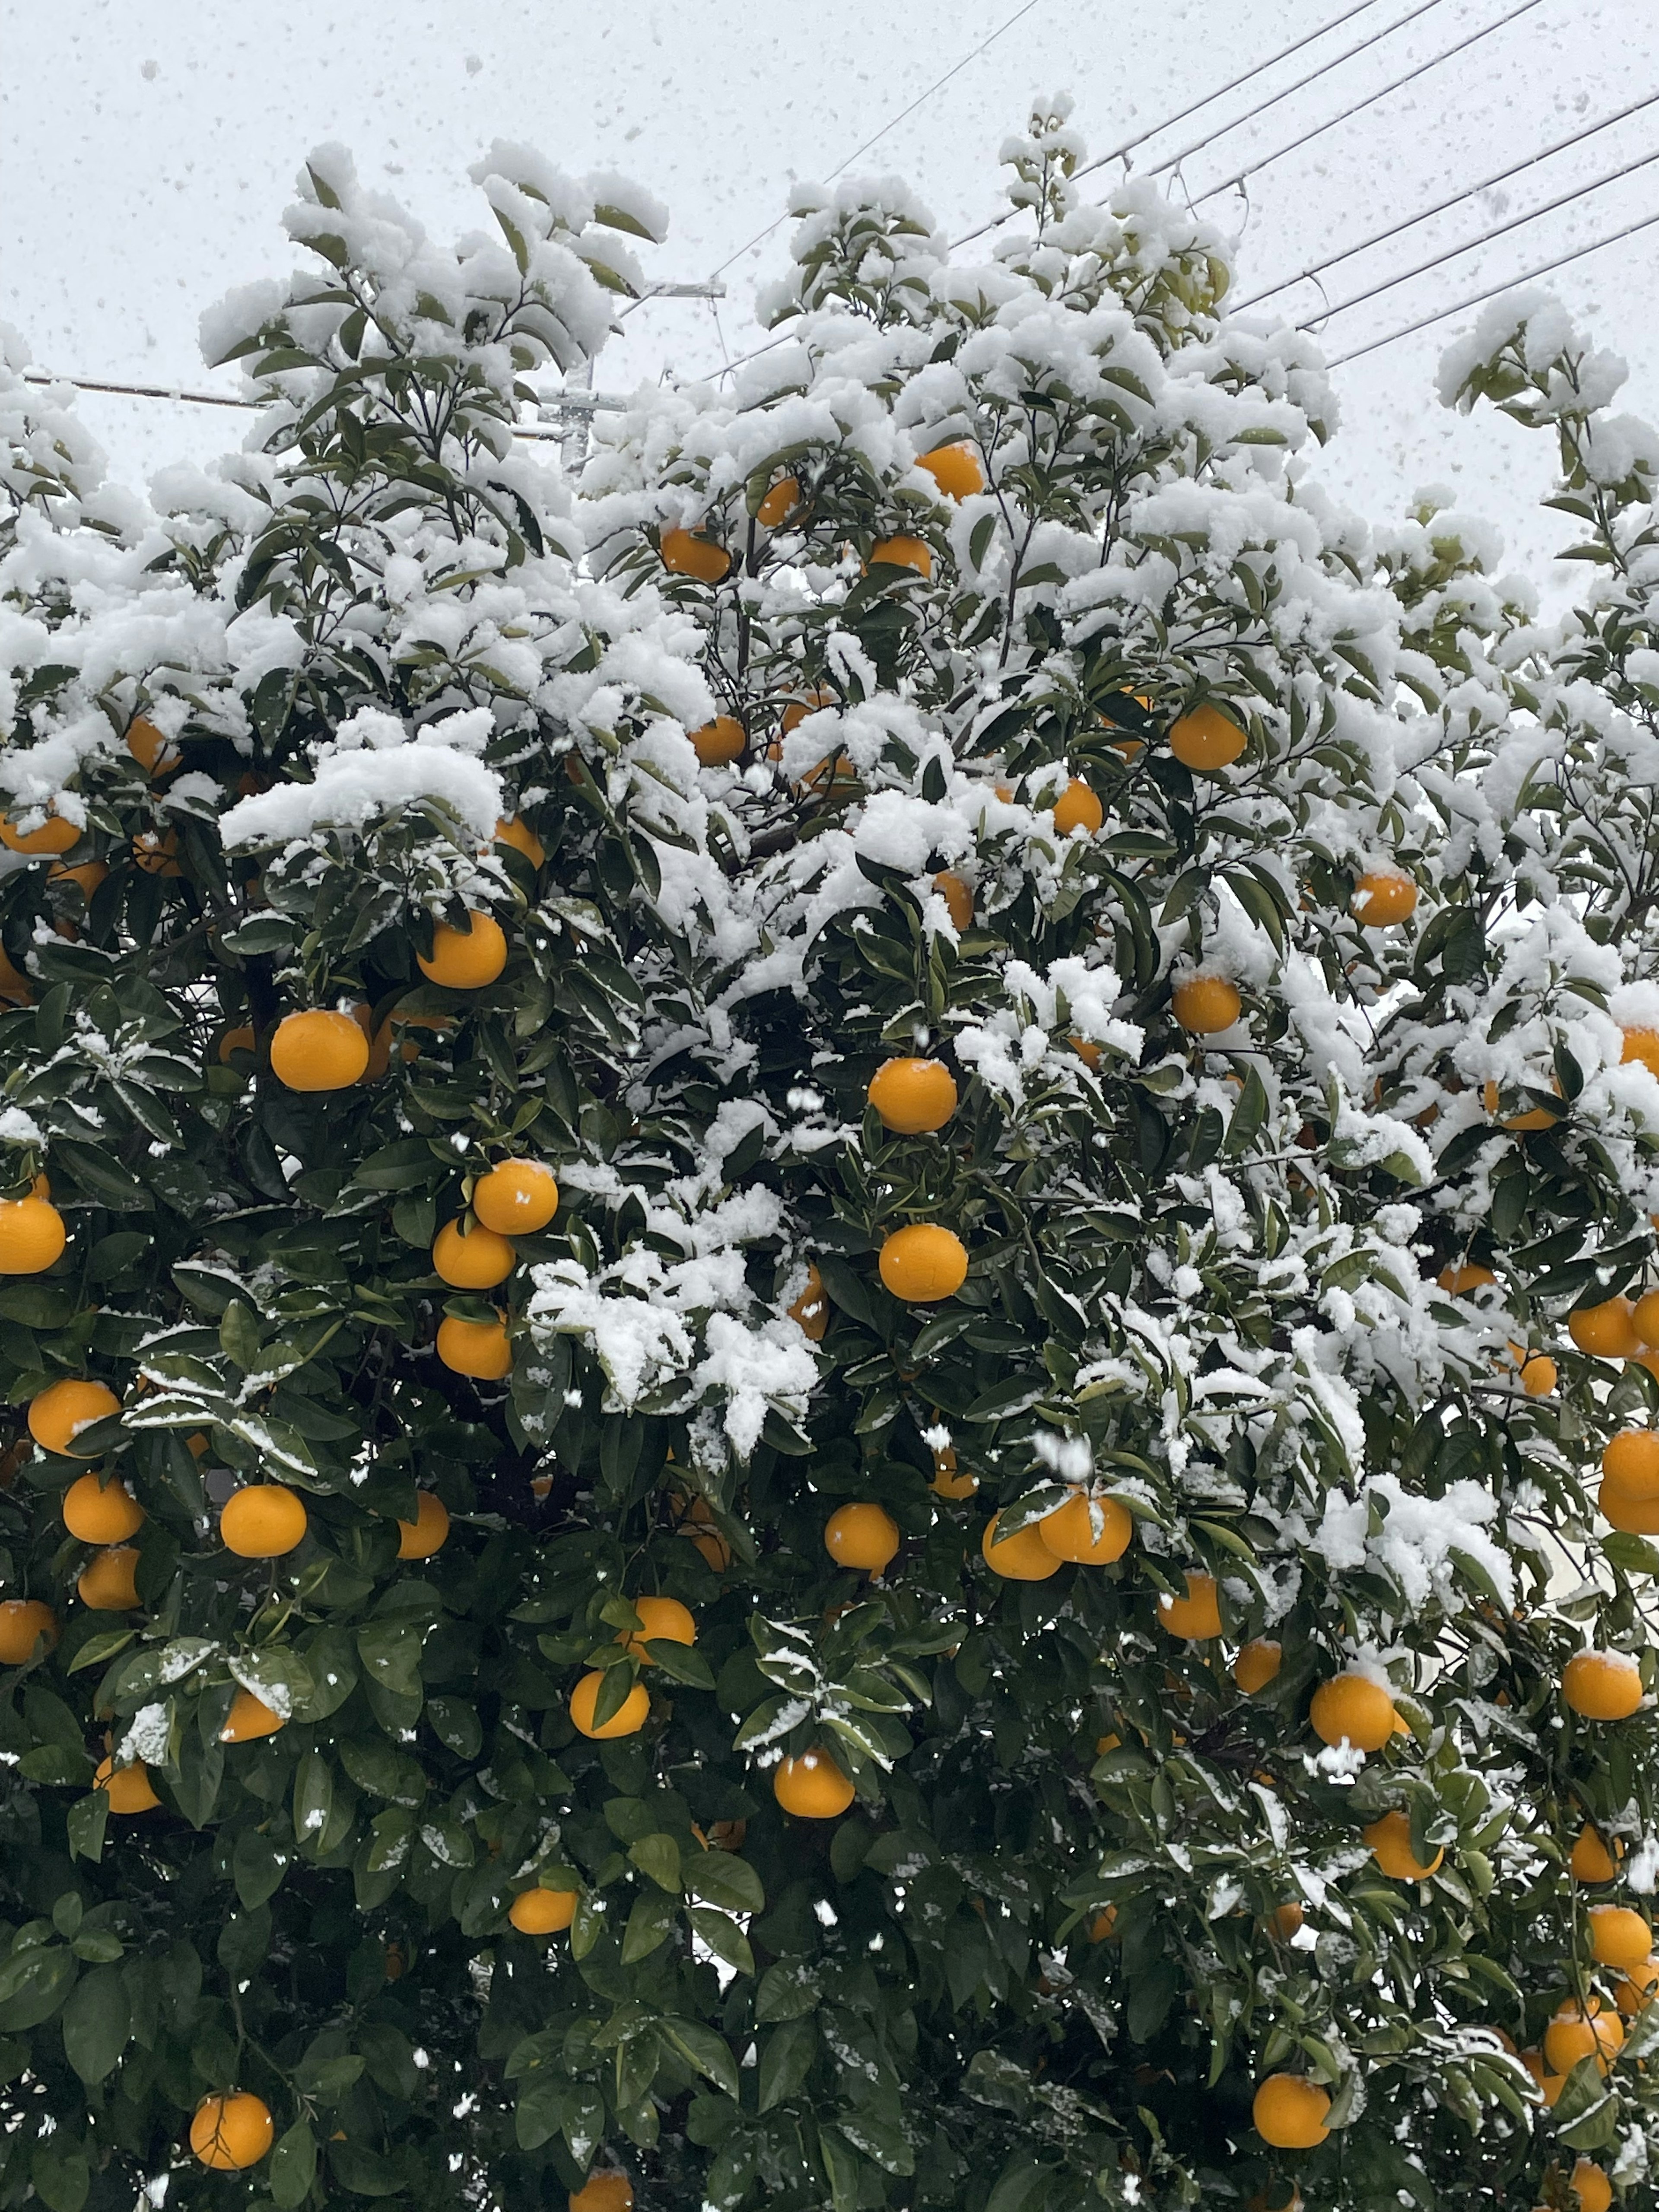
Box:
left=0, top=108, right=1659, bottom=2212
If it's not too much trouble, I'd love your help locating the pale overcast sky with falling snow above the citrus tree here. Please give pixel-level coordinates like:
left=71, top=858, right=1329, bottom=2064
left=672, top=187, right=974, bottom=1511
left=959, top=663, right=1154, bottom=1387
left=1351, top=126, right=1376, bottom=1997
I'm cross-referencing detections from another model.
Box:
left=0, top=0, right=1659, bottom=597
